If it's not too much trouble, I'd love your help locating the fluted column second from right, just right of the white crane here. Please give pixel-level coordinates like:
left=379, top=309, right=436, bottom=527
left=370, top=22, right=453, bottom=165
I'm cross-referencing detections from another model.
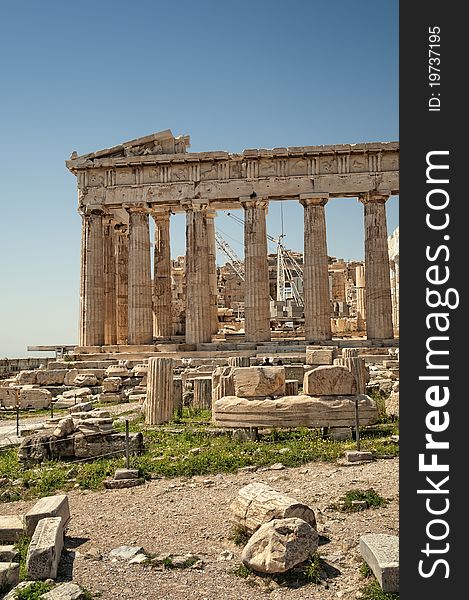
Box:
left=300, top=195, right=332, bottom=341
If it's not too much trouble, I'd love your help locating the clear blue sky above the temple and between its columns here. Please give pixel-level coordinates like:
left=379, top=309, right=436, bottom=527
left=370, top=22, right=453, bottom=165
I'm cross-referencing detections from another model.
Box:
left=0, top=0, right=399, bottom=358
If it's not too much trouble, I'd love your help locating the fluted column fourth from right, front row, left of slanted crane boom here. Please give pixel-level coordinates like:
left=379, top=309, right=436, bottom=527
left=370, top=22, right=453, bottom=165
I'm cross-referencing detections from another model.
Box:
left=186, top=202, right=212, bottom=344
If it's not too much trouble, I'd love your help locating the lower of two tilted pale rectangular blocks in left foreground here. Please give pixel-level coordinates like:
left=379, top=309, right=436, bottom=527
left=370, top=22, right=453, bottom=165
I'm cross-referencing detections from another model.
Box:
left=26, top=517, right=64, bottom=579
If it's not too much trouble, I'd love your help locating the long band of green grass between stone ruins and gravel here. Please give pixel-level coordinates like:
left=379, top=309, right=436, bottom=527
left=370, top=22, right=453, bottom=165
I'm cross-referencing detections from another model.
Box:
left=0, top=408, right=399, bottom=501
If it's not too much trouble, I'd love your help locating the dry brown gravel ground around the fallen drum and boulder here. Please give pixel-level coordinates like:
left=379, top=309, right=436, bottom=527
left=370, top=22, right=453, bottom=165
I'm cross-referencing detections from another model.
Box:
left=1, top=458, right=399, bottom=600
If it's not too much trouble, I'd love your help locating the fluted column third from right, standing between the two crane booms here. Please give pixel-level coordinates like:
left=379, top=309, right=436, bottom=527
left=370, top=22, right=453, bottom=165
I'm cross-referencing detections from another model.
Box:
left=240, top=197, right=270, bottom=342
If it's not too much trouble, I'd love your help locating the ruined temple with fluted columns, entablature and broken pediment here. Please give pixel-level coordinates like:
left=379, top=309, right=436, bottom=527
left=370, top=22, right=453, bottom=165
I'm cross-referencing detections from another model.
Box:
left=66, top=130, right=399, bottom=352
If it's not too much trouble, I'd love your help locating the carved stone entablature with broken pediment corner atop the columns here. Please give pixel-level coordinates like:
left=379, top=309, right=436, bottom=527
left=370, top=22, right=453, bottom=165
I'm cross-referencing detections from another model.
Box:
left=66, top=132, right=399, bottom=212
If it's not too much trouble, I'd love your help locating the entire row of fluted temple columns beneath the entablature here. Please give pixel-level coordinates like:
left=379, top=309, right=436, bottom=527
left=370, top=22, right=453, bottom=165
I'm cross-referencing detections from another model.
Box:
left=80, top=194, right=393, bottom=346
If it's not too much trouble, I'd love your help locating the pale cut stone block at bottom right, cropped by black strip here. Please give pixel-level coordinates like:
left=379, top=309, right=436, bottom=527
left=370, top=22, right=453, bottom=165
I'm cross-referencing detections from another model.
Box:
left=360, top=533, right=399, bottom=593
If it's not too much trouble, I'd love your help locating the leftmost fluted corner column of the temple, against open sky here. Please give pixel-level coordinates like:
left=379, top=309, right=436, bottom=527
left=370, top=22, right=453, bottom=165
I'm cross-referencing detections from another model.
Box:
left=79, top=208, right=104, bottom=346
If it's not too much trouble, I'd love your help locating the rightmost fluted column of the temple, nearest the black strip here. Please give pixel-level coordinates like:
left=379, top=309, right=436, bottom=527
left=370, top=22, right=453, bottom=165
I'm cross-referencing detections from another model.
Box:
left=359, top=193, right=393, bottom=340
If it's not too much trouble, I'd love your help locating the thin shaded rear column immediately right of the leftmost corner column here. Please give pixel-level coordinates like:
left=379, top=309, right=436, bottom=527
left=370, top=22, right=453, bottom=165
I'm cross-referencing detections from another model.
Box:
left=103, top=216, right=117, bottom=346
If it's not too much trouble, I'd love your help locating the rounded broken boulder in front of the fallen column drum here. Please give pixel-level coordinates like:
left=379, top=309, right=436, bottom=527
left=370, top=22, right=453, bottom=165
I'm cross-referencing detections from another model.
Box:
left=241, top=517, right=319, bottom=573
